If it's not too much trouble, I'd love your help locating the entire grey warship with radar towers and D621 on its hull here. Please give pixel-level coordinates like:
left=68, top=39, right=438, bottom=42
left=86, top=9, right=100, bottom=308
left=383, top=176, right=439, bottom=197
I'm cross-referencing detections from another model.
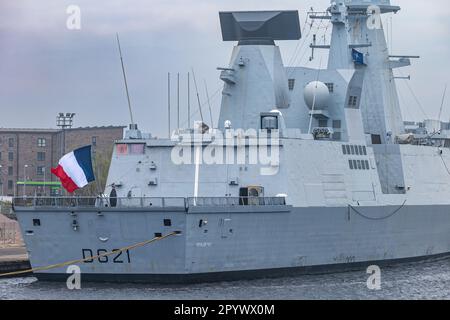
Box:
left=14, top=0, right=450, bottom=283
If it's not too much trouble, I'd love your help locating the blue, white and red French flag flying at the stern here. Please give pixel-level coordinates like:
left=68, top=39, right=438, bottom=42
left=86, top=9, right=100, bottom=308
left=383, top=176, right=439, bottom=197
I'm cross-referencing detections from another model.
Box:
left=51, top=146, right=95, bottom=193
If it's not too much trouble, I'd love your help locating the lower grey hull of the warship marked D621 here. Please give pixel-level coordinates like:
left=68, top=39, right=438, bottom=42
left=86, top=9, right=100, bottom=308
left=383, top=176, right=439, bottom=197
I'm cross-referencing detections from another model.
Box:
left=16, top=205, right=450, bottom=283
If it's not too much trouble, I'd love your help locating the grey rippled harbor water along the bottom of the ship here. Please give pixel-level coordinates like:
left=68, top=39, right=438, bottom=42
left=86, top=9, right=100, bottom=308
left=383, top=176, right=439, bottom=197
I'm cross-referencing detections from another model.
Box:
left=0, top=258, right=450, bottom=300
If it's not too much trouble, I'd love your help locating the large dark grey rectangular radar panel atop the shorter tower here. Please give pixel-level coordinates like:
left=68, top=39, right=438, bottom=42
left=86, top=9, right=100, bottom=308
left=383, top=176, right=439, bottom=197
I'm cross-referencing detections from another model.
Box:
left=219, top=11, right=301, bottom=45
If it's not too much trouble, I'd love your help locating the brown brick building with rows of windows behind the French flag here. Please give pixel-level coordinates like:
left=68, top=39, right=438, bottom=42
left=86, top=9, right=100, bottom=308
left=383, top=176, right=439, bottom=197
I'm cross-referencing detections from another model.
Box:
left=0, top=126, right=124, bottom=196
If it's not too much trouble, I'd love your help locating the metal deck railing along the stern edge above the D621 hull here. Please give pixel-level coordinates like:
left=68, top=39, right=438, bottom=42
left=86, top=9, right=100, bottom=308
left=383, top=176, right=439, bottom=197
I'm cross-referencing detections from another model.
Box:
left=13, top=197, right=286, bottom=209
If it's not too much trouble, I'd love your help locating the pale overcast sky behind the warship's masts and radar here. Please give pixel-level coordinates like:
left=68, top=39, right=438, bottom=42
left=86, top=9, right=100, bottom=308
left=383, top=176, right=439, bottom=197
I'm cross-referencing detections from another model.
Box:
left=0, top=0, right=450, bottom=135
